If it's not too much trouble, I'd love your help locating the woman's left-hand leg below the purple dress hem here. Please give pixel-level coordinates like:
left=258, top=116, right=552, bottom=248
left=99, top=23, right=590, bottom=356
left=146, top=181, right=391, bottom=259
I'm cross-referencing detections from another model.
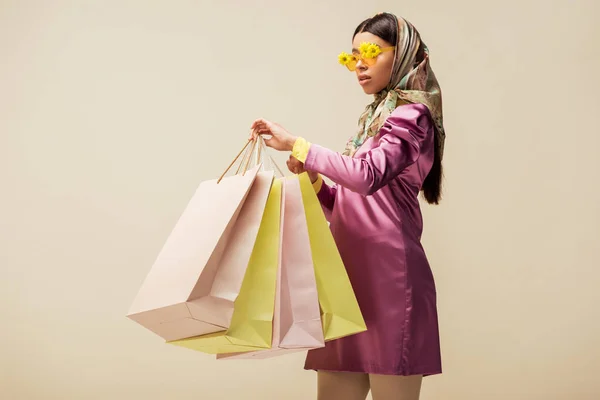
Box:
left=317, top=371, right=369, bottom=400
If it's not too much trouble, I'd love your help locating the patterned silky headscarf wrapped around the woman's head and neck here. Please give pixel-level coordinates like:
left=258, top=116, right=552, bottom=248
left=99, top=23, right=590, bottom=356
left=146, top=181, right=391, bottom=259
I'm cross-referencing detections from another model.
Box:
left=344, top=14, right=446, bottom=159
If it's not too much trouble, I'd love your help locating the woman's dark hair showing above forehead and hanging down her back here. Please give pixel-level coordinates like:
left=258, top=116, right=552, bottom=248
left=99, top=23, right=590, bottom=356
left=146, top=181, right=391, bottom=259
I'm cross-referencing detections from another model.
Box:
left=352, top=13, right=443, bottom=204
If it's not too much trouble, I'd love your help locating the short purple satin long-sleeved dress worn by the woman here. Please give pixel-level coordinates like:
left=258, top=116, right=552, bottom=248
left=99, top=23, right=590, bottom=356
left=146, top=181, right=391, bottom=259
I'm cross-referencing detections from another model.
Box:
left=305, top=104, right=442, bottom=376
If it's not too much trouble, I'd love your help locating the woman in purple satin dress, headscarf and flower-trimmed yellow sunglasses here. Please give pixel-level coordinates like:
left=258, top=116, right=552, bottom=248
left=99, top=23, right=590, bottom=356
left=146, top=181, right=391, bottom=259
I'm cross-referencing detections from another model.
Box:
left=252, top=13, right=445, bottom=400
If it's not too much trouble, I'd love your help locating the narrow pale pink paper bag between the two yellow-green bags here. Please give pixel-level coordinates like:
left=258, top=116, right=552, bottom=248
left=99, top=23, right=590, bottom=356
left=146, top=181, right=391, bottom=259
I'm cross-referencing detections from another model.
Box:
left=217, top=176, right=325, bottom=359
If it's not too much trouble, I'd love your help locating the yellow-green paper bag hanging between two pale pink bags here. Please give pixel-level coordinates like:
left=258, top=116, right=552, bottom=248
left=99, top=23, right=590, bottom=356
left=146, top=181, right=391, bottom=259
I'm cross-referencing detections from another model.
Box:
left=168, top=180, right=283, bottom=354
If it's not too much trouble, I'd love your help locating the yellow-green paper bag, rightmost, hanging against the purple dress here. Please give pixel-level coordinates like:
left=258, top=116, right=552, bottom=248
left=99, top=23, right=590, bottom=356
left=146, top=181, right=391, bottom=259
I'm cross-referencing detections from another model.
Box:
left=299, top=173, right=367, bottom=341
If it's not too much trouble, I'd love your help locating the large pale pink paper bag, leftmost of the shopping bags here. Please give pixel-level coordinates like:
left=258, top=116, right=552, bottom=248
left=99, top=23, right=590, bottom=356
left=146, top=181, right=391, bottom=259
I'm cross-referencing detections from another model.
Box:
left=127, top=162, right=273, bottom=341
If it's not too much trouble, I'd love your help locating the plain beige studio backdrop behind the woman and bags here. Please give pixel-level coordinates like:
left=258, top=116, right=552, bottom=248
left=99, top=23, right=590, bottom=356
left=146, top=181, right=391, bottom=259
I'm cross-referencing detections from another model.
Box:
left=0, top=0, right=600, bottom=400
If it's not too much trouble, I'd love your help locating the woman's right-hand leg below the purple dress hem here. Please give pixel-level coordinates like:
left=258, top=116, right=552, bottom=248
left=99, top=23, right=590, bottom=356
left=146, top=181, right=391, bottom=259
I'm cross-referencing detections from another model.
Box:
left=369, top=375, right=423, bottom=400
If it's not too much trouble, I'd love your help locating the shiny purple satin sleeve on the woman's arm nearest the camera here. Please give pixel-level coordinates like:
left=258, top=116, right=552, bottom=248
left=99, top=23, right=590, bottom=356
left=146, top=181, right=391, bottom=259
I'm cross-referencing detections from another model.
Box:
left=304, top=104, right=430, bottom=197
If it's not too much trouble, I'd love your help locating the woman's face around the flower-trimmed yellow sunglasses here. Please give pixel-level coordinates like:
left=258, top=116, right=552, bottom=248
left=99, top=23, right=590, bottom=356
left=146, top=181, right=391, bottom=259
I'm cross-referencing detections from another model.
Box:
left=352, top=32, right=395, bottom=95
